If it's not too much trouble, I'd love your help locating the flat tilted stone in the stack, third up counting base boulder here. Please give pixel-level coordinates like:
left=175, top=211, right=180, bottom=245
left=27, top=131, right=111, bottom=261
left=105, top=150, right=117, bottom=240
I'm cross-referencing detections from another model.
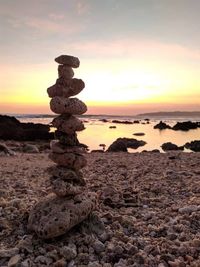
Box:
left=47, top=168, right=85, bottom=185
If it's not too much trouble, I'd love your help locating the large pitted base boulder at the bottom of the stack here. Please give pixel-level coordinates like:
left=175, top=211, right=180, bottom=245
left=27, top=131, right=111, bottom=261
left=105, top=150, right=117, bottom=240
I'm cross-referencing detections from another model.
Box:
left=28, top=192, right=96, bottom=239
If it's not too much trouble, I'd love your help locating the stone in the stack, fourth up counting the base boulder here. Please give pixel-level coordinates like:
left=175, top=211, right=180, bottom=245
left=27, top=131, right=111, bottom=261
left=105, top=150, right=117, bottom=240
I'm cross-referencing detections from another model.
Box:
left=49, top=152, right=87, bottom=170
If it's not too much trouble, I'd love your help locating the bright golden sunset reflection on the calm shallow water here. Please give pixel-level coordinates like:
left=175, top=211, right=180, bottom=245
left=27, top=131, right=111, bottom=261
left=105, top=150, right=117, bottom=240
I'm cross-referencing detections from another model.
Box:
left=20, top=118, right=200, bottom=152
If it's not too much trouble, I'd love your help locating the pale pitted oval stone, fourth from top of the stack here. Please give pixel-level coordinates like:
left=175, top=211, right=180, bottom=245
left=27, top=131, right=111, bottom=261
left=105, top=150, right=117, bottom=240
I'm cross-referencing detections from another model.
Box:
left=50, top=96, right=87, bottom=115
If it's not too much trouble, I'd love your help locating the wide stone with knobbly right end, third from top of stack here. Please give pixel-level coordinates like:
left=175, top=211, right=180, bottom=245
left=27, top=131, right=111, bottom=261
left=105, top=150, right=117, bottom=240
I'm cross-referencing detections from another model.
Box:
left=47, top=77, right=85, bottom=97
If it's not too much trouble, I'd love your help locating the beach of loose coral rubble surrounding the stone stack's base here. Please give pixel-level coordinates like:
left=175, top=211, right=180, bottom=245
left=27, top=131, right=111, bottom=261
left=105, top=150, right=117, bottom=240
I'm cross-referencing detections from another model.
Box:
left=0, top=151, right=200, bottom=267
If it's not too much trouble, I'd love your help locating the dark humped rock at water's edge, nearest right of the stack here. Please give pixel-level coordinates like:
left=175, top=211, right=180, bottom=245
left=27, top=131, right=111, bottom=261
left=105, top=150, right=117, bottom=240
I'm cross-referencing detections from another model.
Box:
left=107, top=137, right=146, bottom=152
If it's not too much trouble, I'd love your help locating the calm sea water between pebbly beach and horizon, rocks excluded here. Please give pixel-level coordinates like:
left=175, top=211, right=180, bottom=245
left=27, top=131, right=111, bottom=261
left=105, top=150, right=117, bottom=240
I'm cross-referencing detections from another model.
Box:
left=15, top=114, right=200, bottom=152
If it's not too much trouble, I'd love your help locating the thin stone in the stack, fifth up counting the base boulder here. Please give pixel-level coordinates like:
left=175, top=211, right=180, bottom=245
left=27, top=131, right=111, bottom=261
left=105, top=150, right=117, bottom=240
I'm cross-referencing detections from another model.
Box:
left=50, top=140, right=85, bottom=154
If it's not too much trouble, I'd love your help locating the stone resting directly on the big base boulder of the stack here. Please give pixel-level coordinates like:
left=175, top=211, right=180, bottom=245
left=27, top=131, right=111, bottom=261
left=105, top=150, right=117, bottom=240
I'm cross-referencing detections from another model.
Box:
left=51, top=177, right=84, bottom=197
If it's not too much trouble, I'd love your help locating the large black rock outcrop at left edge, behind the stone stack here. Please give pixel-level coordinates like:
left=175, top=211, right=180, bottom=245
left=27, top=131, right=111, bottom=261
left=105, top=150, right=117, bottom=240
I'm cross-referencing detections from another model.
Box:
left=0, top=115, right=54, bottom=141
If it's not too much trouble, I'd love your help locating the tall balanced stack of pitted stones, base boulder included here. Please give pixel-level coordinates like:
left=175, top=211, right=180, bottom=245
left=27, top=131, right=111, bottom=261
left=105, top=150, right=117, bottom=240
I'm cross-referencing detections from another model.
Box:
left=28, top=55, right=96, bottom=239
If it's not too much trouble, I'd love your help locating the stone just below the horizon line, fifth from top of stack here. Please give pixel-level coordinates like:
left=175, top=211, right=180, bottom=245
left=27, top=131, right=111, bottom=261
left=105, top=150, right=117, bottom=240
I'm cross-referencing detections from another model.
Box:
left=51, top=114, right=85, bottom=134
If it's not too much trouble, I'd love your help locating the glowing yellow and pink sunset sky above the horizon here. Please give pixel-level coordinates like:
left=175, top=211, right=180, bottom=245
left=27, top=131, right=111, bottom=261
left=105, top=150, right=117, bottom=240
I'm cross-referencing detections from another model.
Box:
left=0, top=0, right=200, bottom=115
